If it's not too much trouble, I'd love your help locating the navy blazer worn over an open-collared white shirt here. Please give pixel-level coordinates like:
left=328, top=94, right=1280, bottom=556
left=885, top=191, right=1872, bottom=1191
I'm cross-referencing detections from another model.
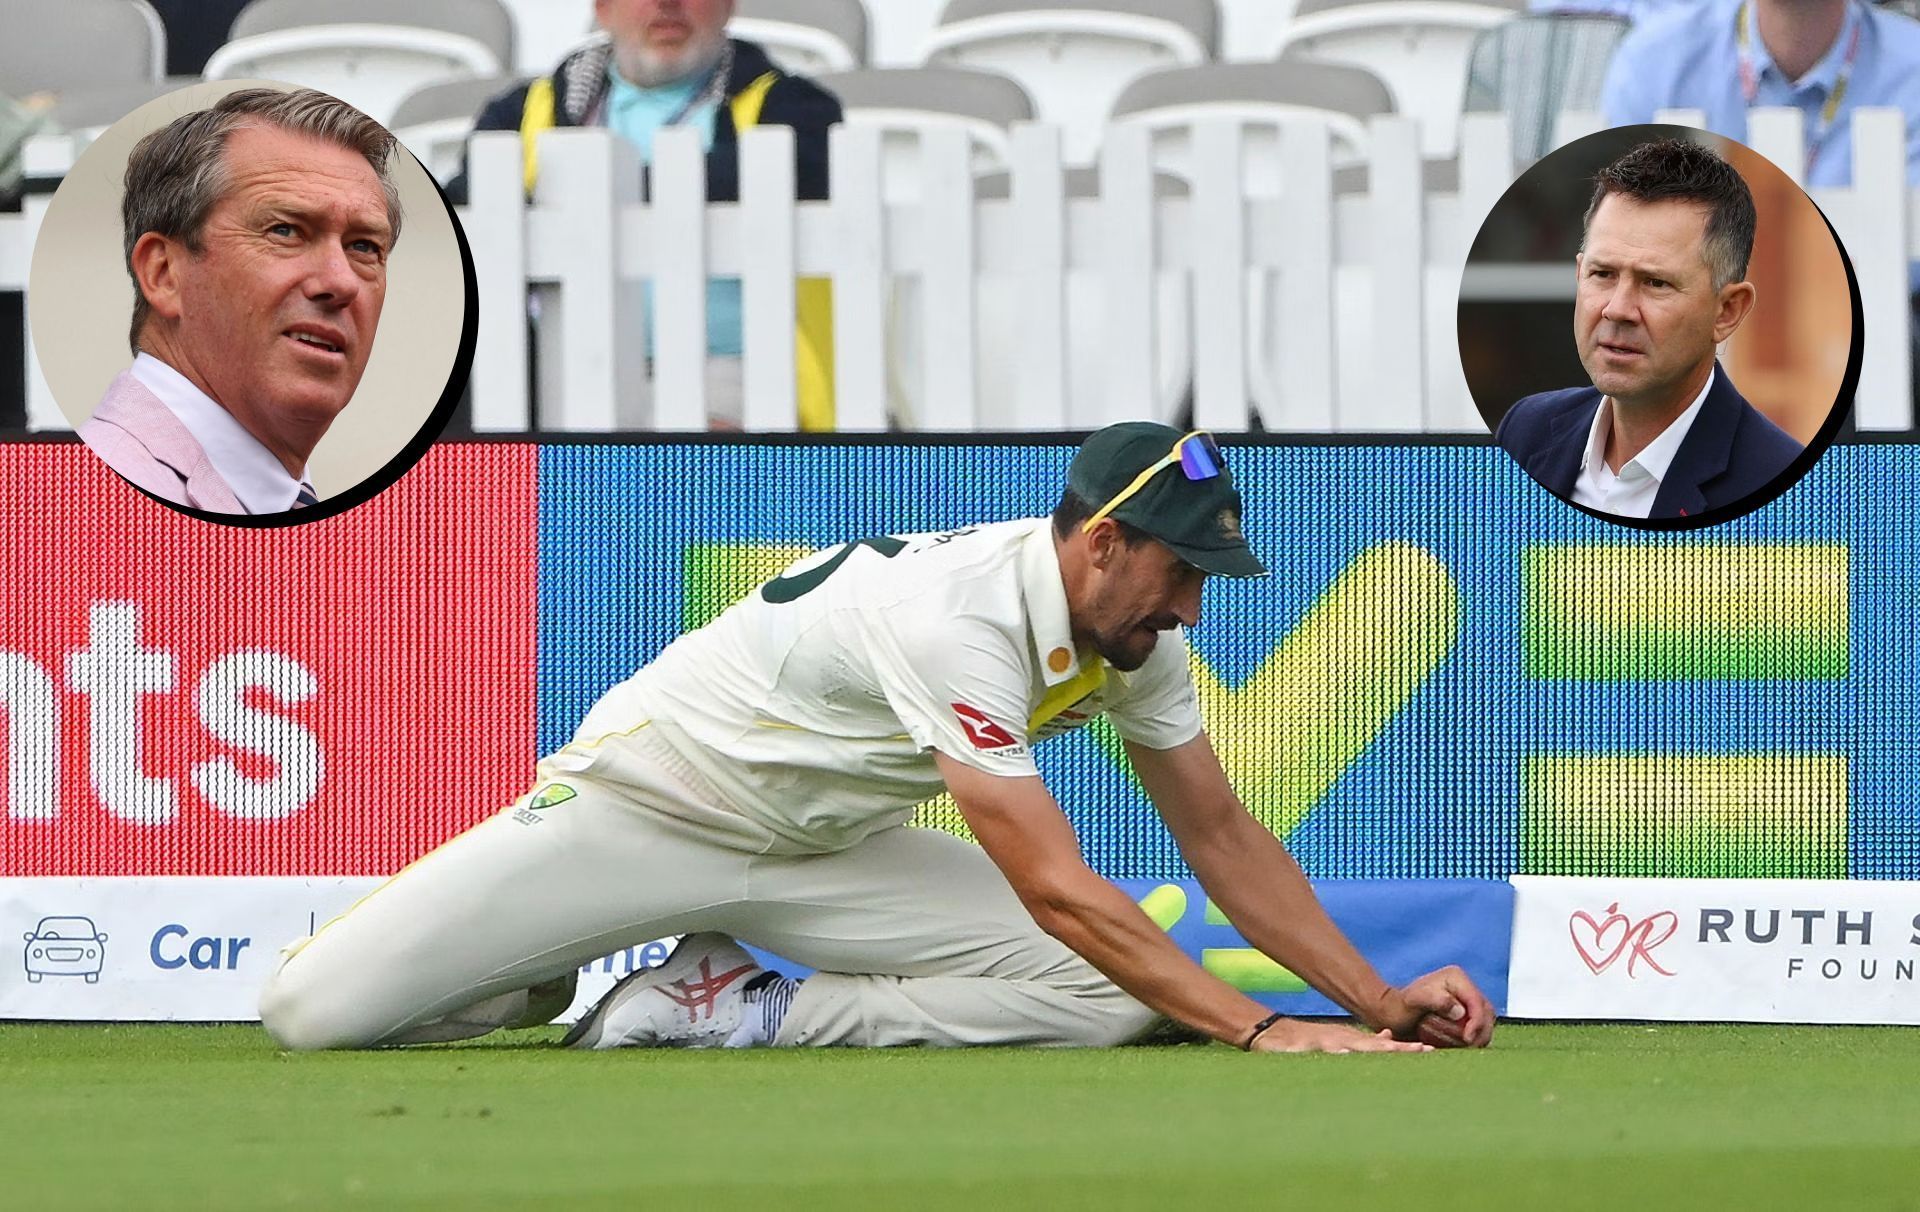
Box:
left=1494, top=363, right=1805, bottom=519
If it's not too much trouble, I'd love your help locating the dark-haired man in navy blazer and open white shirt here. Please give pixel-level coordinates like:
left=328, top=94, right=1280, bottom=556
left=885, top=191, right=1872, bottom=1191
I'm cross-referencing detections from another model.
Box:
left=1496, top=140, right=1803, bottom=519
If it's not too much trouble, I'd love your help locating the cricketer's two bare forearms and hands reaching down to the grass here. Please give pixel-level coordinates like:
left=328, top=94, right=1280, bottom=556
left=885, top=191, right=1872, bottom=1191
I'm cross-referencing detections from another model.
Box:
left=933, top=732, right=1492, bottom=1053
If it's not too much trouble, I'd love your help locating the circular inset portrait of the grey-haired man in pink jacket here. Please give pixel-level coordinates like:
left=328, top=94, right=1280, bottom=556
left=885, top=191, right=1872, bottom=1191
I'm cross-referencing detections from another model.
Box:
left=27, top=81, right=474, bottom=526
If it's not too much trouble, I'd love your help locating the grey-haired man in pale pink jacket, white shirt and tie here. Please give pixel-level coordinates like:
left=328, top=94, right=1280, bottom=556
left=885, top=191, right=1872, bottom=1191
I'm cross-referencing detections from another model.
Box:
left=81, top=88, right=401, bottom=515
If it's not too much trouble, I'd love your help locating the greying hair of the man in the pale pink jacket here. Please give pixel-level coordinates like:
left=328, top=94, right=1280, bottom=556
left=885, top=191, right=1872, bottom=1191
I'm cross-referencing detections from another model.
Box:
left=121, top=88, right=401, bottom=353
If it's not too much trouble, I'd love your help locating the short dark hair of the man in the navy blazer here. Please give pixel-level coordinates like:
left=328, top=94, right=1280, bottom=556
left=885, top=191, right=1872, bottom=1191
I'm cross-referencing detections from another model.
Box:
left=1580, top=138, right=1757, bottom=290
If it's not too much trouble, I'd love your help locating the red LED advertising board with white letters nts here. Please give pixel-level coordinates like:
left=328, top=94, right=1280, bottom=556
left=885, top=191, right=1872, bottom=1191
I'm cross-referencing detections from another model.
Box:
left=0, top=444, right=538, bottom=876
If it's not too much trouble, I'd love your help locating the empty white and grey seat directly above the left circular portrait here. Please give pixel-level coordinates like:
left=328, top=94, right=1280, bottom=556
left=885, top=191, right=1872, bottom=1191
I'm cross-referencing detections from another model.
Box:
left=207, top=0, right=513, bottom=123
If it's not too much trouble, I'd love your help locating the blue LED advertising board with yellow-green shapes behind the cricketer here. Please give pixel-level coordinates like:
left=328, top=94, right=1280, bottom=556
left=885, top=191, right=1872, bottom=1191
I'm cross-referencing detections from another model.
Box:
left=538, top=438, right=1920, bottom=880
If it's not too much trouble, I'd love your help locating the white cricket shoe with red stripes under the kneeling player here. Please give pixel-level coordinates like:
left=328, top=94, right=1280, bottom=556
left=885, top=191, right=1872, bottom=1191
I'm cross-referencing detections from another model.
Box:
left=561, top=933, right=764, bottom=1049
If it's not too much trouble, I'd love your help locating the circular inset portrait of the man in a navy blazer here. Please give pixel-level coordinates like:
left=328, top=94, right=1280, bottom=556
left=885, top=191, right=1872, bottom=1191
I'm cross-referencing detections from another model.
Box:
left=1459, top=125, right=1860, bottom=530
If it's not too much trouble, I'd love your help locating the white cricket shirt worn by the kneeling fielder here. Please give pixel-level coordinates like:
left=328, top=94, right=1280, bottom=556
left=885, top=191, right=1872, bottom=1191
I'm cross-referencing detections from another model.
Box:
left=563, top=519, right=1200, bottom=851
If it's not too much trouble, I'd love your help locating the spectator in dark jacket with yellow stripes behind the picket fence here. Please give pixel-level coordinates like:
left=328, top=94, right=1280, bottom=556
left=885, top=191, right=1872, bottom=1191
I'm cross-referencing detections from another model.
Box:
left=447, top=0, right=841, bottom=430
